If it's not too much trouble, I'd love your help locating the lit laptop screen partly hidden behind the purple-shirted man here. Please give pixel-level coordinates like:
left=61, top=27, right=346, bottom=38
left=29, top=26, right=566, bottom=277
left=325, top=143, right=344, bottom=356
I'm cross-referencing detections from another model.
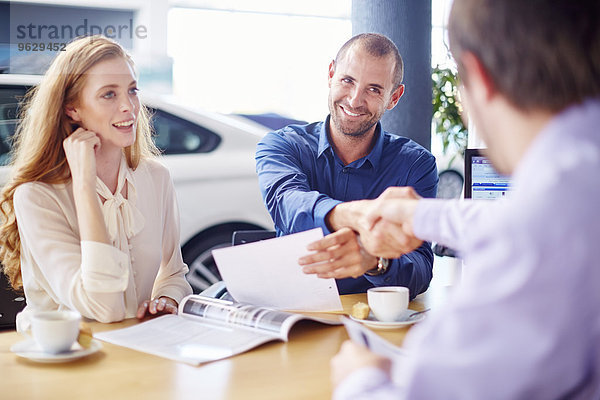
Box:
left=465, top=149, right=510, bottom=200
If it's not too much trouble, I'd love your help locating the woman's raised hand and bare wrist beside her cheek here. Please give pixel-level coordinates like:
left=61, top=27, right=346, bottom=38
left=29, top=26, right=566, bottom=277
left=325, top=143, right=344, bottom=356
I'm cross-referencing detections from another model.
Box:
left=63, top=128, right=100, bottom=191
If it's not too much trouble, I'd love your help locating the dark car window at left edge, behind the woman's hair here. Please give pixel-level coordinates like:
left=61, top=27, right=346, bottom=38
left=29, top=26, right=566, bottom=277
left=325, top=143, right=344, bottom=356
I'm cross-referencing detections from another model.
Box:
left=0, top=85, right=27, bottom=165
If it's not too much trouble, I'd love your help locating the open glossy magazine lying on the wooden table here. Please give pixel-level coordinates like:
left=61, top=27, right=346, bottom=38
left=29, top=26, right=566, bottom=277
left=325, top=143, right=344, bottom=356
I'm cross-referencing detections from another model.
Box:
left=94, top=295, right=341, bottom=365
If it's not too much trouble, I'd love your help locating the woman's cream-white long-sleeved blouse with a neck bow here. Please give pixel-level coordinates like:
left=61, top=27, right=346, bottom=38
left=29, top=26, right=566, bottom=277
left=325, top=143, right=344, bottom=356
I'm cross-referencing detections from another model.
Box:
left=14, top=158, right=192, bottom=322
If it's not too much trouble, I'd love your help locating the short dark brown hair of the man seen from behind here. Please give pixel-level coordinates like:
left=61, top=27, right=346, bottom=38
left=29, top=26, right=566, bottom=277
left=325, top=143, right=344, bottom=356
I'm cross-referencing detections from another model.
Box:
left=448, top=0, right=600, bottom=112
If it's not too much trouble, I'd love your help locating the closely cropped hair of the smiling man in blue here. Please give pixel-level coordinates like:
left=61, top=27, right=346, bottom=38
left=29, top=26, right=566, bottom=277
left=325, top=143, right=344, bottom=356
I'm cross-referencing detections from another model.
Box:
left=335, top=33, right=404, bottom=90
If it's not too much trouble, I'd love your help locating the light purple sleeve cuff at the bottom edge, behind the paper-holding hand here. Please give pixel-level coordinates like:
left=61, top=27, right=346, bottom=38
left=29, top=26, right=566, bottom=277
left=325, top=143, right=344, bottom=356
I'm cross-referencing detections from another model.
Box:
left=333, top=367, right=391, bottom=400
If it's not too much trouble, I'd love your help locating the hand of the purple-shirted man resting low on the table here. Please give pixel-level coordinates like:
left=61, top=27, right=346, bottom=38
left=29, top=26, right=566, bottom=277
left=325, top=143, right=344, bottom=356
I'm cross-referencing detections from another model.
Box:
left=331, top=340, right=391, bottom=387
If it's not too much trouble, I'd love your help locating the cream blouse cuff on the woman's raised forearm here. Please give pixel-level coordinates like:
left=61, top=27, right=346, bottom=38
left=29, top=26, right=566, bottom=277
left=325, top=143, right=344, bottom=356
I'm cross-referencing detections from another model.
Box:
left=81, top=240, right=129, bottom=293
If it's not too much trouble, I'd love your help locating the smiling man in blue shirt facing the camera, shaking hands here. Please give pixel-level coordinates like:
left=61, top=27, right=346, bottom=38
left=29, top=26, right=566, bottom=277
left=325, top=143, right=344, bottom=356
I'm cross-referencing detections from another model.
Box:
left=256, top=33, right=438, bottom=297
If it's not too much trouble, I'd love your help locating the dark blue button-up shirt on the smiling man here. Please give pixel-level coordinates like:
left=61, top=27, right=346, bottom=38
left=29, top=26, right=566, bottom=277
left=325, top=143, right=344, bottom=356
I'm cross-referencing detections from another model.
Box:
left=256, top=117, right=438, bottom=297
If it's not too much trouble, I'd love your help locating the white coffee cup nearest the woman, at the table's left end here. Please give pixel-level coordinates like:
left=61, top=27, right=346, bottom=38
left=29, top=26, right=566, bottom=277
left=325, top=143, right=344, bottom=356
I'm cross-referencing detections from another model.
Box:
left=18, top=310, right=81, bottom=354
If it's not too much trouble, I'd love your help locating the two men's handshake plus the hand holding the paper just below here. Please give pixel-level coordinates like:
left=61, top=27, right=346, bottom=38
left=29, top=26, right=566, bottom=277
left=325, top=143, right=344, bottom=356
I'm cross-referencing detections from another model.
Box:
left=299, top=187, right=423, bottom=279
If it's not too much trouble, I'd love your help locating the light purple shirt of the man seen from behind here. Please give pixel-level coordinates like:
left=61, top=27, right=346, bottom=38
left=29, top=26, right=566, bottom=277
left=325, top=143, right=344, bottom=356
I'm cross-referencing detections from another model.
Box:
left=334, top=99, right=600, bottom=400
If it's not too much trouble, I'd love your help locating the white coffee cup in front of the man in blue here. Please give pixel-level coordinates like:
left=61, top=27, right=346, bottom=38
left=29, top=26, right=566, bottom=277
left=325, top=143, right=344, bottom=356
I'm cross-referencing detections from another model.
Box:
left=367, top=286, right=408, bottom=322
